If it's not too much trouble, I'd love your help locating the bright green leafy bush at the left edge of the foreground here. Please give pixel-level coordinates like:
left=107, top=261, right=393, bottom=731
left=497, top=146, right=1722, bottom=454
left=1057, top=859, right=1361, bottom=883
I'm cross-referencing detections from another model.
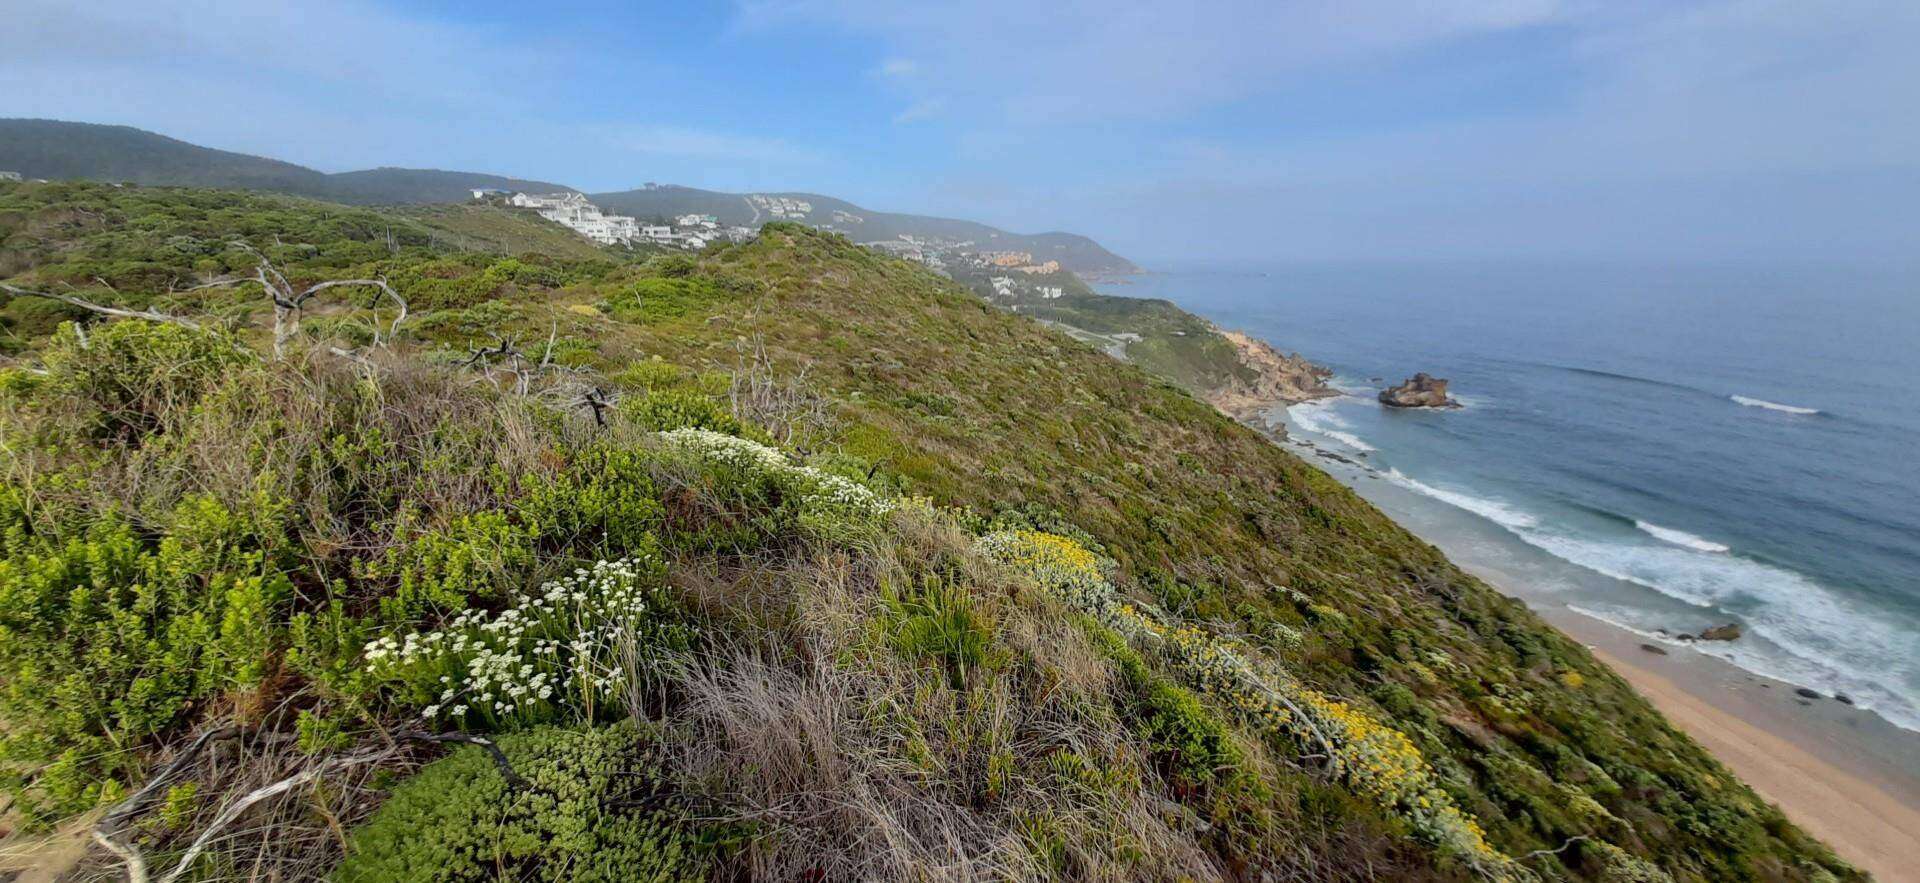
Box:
left=0, top=488, right=292, bottom=822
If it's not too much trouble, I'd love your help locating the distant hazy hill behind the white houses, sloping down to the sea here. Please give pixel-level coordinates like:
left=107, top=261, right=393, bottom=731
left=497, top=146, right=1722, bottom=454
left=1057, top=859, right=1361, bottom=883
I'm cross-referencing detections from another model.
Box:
left=591, top=184, right=1139, bottom=273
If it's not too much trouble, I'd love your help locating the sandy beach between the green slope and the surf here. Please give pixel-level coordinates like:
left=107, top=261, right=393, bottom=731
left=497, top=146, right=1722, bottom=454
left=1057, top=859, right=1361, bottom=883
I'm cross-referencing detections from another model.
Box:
left=1275, top=416, right=1920, bottom=883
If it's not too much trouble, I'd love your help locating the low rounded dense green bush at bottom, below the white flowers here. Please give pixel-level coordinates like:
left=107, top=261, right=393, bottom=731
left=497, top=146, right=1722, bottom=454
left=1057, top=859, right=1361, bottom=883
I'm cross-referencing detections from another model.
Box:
left=334, top=728, right=705, bottom=883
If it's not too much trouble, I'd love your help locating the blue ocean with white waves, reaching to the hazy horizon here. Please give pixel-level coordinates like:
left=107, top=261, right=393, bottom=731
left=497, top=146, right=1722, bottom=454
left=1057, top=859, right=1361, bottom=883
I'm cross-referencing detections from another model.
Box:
left=1100, top=263, right=1920, bottom=729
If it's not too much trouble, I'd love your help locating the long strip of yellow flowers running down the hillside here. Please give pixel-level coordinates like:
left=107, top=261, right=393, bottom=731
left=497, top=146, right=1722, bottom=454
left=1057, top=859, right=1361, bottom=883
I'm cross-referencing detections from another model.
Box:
left=977, top=530, right=1517, bottom=877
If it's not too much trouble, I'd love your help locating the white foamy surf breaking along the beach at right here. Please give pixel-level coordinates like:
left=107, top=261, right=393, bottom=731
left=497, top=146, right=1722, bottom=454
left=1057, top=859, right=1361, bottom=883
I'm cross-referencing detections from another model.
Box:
left=1386, top=470, right=1920, bottom=729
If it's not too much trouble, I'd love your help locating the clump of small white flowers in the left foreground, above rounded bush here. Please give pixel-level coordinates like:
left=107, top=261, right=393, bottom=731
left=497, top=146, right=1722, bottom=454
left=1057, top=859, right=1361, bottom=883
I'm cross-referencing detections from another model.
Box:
left=367, top=559, right=672, bottom=724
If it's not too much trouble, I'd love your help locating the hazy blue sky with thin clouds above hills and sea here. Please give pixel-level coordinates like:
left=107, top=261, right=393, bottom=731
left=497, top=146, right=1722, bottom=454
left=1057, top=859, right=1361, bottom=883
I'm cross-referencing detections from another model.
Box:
left=0, top=0, right=1920, bottom=265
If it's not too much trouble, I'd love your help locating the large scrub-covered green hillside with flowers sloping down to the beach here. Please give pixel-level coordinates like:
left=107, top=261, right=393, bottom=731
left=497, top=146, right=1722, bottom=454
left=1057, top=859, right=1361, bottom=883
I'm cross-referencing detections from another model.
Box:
left=0, top=182, right=1862, bottom=881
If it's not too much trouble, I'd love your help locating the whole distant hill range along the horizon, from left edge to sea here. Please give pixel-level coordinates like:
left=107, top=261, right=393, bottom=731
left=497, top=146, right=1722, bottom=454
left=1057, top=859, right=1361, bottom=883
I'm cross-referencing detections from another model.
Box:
left=0, top=119, right=1139, bottom=273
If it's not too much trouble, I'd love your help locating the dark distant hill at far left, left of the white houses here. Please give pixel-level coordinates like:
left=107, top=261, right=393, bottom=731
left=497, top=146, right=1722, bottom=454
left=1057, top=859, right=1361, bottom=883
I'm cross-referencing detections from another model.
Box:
left=0, top=119, right=572, bottom=205
